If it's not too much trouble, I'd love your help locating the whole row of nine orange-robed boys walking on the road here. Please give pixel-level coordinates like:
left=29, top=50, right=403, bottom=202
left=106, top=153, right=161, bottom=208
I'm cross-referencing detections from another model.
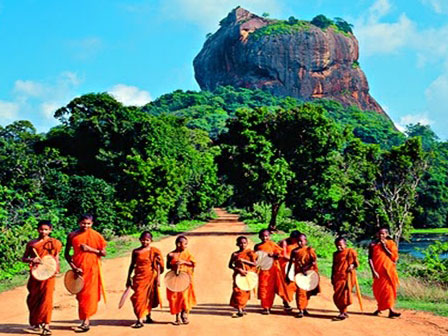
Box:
left=22, top=215, right=400, bottom=335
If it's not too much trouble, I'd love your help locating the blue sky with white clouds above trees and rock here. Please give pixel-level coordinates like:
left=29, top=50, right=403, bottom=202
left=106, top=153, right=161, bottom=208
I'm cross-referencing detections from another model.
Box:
left=0, top=0, right=448, bottom=140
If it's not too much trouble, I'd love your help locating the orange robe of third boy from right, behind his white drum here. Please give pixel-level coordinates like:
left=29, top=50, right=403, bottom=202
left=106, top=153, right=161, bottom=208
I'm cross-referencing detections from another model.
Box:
left=294, top=246, right=320, bottom=310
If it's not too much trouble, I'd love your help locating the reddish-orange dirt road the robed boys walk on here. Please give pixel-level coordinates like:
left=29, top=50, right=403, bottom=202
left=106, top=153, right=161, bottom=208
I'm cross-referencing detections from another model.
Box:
left=0, top=210, right=448, bottom=336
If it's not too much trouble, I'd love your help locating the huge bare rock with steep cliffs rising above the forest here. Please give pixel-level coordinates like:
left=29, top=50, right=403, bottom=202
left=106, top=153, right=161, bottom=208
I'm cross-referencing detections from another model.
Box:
left=193, top=7, right=385, bottom=114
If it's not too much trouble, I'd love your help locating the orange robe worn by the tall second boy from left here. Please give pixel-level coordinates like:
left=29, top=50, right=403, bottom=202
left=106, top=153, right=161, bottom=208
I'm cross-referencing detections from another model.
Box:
left=72, top=229, right=107, bottom=320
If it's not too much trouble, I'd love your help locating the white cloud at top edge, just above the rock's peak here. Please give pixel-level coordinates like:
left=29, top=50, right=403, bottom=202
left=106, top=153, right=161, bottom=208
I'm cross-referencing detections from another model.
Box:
left=164, top=0, right=281, bottom=31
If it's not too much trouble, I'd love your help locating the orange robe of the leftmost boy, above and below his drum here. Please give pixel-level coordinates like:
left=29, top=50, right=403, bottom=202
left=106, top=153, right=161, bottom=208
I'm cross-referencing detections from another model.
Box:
left=26, top=238, right=62, bottom=326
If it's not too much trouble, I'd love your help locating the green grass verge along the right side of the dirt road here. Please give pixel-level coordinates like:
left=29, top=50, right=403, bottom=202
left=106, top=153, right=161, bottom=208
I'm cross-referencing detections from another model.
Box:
left=236, top=210, right=448, bottom=316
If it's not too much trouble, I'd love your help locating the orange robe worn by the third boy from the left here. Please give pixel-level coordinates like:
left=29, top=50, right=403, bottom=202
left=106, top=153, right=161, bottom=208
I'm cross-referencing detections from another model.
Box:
left=131, top=247, right=163, bottom=319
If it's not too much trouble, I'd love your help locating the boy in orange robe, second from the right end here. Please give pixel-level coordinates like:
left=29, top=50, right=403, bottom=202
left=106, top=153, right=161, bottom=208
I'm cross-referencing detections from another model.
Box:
left=331, top=237, right=359, bottom=320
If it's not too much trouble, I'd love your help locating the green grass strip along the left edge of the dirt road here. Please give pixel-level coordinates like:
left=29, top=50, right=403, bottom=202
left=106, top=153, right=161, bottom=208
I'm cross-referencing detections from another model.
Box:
left=0, top=220, right=205, bottom=293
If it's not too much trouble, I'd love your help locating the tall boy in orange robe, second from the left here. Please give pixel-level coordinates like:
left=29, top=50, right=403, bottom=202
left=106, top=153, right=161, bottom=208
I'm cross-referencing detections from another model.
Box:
left=65, top=214, right=107, bottom=332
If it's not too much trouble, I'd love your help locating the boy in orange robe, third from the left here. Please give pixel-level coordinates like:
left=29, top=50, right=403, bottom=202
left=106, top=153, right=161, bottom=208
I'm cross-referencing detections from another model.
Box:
left=126, top=231, right=163, bottom=328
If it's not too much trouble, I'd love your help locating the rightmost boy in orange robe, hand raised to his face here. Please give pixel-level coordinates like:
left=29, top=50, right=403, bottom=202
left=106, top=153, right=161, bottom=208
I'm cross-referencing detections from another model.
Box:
left=369, top=228, right=401, bottom=318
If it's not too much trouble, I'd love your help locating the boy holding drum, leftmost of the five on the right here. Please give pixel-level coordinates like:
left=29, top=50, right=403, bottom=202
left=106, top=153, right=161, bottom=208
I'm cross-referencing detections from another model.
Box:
left=229, top=236, right=257, bottom=318
